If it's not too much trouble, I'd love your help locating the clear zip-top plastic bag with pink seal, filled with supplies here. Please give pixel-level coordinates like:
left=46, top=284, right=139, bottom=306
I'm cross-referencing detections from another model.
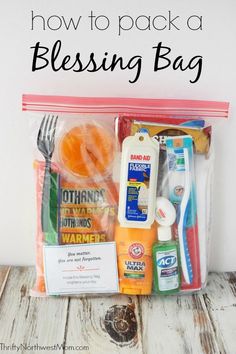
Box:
left=23, top=95, right=228, bottom=296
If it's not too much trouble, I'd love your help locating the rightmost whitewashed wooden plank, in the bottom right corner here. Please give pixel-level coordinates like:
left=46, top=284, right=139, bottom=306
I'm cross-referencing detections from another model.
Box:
left=203, top=272, right=236, bottom=354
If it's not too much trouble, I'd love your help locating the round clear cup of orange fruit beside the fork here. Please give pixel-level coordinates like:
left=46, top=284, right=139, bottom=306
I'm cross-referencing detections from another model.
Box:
left=59, top=124, right=115, bottom=177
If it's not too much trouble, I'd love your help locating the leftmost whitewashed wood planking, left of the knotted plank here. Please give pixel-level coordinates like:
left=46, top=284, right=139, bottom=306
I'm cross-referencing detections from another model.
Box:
left=0, top=267, right=68, bottom=353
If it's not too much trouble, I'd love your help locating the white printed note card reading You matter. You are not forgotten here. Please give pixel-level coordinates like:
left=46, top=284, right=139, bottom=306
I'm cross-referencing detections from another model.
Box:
left=44, top=242, right=119, bottom=295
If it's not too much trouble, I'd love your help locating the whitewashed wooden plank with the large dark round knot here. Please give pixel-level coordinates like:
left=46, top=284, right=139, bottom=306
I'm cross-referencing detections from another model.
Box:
left=66, top=296, right=143, bottom=354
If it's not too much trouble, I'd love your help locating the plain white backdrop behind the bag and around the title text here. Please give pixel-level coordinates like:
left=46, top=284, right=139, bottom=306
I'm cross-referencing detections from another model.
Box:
left=0, top=0, right=236, bottom=270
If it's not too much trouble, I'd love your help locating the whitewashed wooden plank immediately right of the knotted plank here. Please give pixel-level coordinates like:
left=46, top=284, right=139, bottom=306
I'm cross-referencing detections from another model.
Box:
left=139, top=295, right=220, bottom=354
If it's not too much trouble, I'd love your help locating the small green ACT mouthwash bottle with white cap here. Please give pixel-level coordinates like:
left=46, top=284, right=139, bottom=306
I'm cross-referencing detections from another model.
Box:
left=152, top=226, right=180, bottom=295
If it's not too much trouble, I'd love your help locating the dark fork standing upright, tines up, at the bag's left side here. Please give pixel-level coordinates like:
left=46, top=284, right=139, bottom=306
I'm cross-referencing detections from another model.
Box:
left=37, top=114, right=58, bottom=233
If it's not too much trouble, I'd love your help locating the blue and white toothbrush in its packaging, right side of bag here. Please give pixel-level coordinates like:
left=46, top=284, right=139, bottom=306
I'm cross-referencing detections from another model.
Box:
left=166, top=136, right=200, bottom=289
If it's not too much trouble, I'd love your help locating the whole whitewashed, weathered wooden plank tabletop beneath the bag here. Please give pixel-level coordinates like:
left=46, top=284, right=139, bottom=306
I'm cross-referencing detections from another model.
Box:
left=0, top=266, right=236, bottom=354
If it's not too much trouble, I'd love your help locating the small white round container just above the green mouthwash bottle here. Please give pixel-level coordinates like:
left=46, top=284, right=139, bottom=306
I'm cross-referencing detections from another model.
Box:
left=155, top=197, right=176, bottom=226
